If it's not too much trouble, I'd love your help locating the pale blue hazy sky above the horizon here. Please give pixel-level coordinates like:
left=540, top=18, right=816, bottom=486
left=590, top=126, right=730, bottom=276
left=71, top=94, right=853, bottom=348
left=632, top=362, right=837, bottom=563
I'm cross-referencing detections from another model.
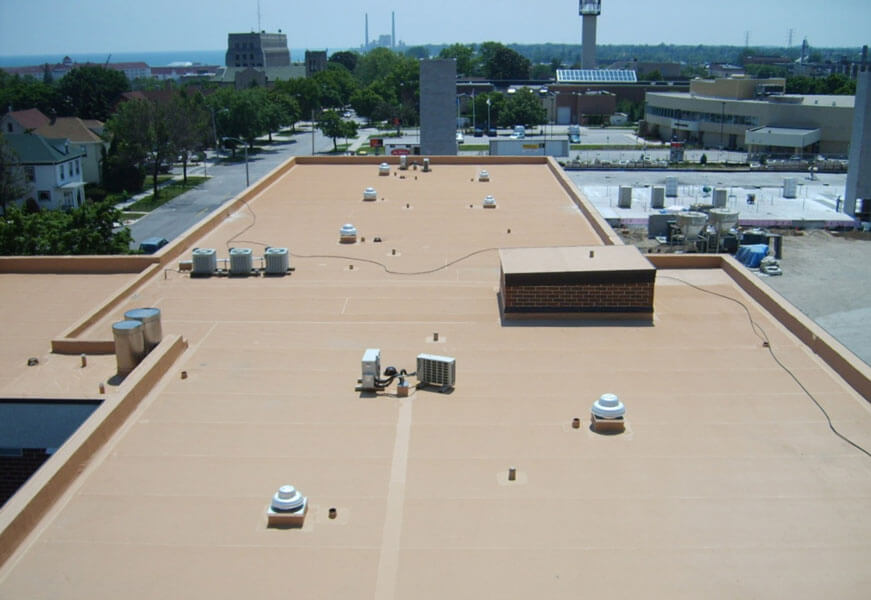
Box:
left=0, top=0, right=871, bottom=56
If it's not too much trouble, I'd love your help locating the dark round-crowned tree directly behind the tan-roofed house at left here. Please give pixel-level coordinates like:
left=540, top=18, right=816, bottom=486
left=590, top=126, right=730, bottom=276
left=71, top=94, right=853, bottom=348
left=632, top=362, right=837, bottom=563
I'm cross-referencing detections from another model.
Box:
left=58, top=66, right=130, bottom=121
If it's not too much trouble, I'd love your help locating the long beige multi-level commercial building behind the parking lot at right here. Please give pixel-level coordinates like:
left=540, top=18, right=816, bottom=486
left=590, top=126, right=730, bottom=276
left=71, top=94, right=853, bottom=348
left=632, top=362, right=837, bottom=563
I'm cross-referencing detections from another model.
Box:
left=644, top=78, right=854, bottom=156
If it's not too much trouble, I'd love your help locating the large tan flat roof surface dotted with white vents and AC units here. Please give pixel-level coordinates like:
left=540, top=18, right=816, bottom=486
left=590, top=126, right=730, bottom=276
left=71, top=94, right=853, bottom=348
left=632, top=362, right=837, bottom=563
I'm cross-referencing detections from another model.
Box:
left=0, top=157, right=871, bottom=599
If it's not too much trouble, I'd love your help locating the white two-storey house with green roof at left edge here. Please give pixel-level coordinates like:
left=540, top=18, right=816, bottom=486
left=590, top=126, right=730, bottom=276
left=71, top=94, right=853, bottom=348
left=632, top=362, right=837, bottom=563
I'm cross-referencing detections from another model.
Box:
left=4, top=133, right=85, bottom=210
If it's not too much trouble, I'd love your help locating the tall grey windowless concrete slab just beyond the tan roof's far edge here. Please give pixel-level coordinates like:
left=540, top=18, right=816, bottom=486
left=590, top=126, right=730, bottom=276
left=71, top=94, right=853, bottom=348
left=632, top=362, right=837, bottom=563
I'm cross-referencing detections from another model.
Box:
left=420, top=59, right=457, bottom=156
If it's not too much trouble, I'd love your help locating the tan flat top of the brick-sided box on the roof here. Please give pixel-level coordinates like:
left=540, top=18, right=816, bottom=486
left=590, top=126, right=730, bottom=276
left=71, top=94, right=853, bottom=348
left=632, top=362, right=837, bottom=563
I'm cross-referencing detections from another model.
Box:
left=499, top=246, right=653, bottom=274
